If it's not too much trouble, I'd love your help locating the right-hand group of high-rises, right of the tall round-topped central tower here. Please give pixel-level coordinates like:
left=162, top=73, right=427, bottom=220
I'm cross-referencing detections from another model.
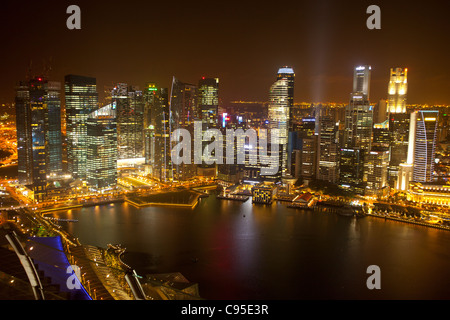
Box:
left=282, top=65, right=439, bottom=196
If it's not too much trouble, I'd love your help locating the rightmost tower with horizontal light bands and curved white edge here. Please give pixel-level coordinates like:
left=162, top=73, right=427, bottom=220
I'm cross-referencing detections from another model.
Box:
left=413, top=110, right=439, bottom=182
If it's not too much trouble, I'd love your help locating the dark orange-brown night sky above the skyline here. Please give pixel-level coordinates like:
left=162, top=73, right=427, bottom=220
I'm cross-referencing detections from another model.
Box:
left=0, top=0, right=450, bottom=105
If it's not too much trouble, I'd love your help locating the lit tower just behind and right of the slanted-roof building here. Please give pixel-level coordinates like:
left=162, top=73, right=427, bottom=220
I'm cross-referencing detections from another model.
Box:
left=111, top=83, right=145, bottom=160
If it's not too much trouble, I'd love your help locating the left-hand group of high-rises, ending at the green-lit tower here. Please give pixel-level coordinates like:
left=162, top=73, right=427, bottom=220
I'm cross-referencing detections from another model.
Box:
left=15, top=75, right=223, bottom=202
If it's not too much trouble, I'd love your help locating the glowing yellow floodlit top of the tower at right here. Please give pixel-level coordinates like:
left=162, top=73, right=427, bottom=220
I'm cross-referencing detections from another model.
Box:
left=388, top=68, right=408, bottom=113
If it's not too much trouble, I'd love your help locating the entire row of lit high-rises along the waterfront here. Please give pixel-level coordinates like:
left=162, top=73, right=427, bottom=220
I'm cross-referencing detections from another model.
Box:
left=15, top=66, right=439, bottom=201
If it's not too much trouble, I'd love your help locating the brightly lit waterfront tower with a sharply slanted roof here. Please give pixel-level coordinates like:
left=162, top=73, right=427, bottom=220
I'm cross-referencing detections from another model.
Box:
left=86, top=102, right=118, bottom=191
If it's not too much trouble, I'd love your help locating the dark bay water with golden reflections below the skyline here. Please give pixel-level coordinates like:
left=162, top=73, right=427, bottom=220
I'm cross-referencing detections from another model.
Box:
left=50, top=195, right=450, bottom=300
